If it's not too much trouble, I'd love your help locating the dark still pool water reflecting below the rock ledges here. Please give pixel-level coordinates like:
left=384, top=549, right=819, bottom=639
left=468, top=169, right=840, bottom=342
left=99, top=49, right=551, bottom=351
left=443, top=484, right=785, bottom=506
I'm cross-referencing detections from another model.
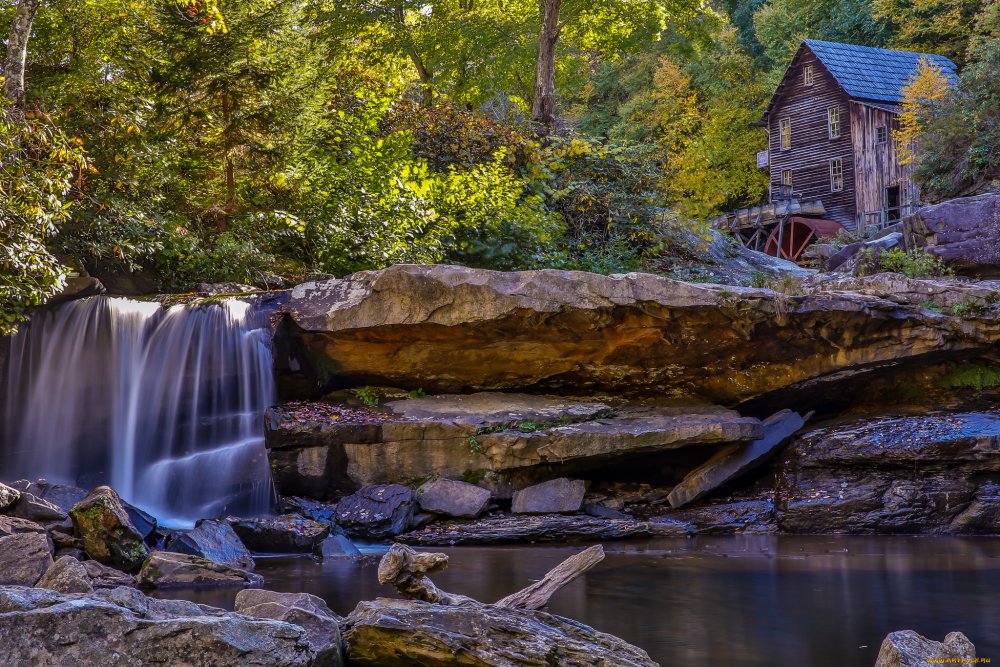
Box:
left=160, top=536, right=1000, bottom=667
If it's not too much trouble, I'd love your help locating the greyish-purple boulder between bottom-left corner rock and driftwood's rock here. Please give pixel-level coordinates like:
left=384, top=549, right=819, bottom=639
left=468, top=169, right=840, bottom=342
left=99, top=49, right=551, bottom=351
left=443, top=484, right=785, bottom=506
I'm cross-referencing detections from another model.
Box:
left=235, top=589, right=344, bottom=667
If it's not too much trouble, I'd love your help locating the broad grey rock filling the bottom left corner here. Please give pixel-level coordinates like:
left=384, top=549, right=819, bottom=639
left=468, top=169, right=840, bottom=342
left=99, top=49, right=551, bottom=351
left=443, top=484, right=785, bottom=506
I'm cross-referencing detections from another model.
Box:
left=0, top=588, right=314, bottom=667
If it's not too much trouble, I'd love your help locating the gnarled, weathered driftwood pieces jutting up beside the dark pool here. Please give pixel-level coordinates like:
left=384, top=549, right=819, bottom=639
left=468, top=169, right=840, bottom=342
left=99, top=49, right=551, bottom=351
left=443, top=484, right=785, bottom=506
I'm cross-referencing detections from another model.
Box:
left=378, top=544, right=604, bottom=610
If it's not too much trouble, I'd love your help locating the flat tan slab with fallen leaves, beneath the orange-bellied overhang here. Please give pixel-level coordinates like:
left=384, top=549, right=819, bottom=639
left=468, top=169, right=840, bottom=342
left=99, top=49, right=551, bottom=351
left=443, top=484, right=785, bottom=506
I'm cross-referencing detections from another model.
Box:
left=265, top=393, right=763, bottom=499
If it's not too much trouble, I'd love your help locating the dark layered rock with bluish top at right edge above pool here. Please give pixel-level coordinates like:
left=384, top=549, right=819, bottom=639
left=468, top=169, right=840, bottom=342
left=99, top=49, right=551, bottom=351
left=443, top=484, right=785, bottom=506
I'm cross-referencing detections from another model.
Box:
left=775, top=413, right=1000, bottom=534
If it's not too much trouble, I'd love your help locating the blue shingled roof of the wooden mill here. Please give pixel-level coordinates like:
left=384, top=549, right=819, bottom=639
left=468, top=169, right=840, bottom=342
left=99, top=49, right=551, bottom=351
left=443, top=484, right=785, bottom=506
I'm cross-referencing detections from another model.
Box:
left=805, top=39, right=958, bottom=104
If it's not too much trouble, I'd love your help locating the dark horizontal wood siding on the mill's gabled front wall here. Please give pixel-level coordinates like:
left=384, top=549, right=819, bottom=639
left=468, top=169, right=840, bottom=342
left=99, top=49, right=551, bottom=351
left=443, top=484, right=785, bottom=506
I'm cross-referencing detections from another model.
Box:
left=767, top=47, right=856, bottom=229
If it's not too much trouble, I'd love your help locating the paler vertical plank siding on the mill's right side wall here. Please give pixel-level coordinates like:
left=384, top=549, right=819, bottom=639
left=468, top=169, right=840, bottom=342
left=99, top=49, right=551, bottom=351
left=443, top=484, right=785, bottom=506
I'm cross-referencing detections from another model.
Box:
left=851, top=102, right=919, bottom=222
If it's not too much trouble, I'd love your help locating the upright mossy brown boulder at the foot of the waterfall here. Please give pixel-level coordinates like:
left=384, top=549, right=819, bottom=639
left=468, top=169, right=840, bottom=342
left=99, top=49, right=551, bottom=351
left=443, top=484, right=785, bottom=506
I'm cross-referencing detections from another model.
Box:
left=70, top=486, right=149, bottom=572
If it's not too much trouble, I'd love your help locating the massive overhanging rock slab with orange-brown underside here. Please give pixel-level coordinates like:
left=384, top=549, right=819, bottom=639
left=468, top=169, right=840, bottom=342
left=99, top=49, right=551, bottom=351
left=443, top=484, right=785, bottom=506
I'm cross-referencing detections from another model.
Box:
left=284, top=265, right=1000, bottom=404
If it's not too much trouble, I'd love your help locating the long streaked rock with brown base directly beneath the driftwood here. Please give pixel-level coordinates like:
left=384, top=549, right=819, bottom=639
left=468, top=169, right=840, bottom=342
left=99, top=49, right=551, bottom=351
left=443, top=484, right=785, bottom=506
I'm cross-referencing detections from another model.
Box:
left=344, top=598, right=656, bottom=667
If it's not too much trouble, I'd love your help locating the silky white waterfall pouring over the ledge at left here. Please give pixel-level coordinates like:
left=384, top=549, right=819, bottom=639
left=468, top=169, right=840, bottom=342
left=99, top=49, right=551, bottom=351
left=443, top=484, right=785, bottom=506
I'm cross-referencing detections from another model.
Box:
left=3, top=297, right=274, bottom=526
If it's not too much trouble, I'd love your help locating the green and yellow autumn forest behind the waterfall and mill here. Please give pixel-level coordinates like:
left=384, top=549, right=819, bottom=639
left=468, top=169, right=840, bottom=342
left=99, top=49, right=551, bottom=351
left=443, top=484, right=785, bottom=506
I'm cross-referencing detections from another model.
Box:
left=0, top=0, right=1000, bottom=328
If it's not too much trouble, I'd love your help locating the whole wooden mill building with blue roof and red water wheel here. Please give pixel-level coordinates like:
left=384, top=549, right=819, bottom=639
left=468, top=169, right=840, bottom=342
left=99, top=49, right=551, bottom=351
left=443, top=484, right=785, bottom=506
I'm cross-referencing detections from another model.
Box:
left=718, top=39, right=956, bottom=259
